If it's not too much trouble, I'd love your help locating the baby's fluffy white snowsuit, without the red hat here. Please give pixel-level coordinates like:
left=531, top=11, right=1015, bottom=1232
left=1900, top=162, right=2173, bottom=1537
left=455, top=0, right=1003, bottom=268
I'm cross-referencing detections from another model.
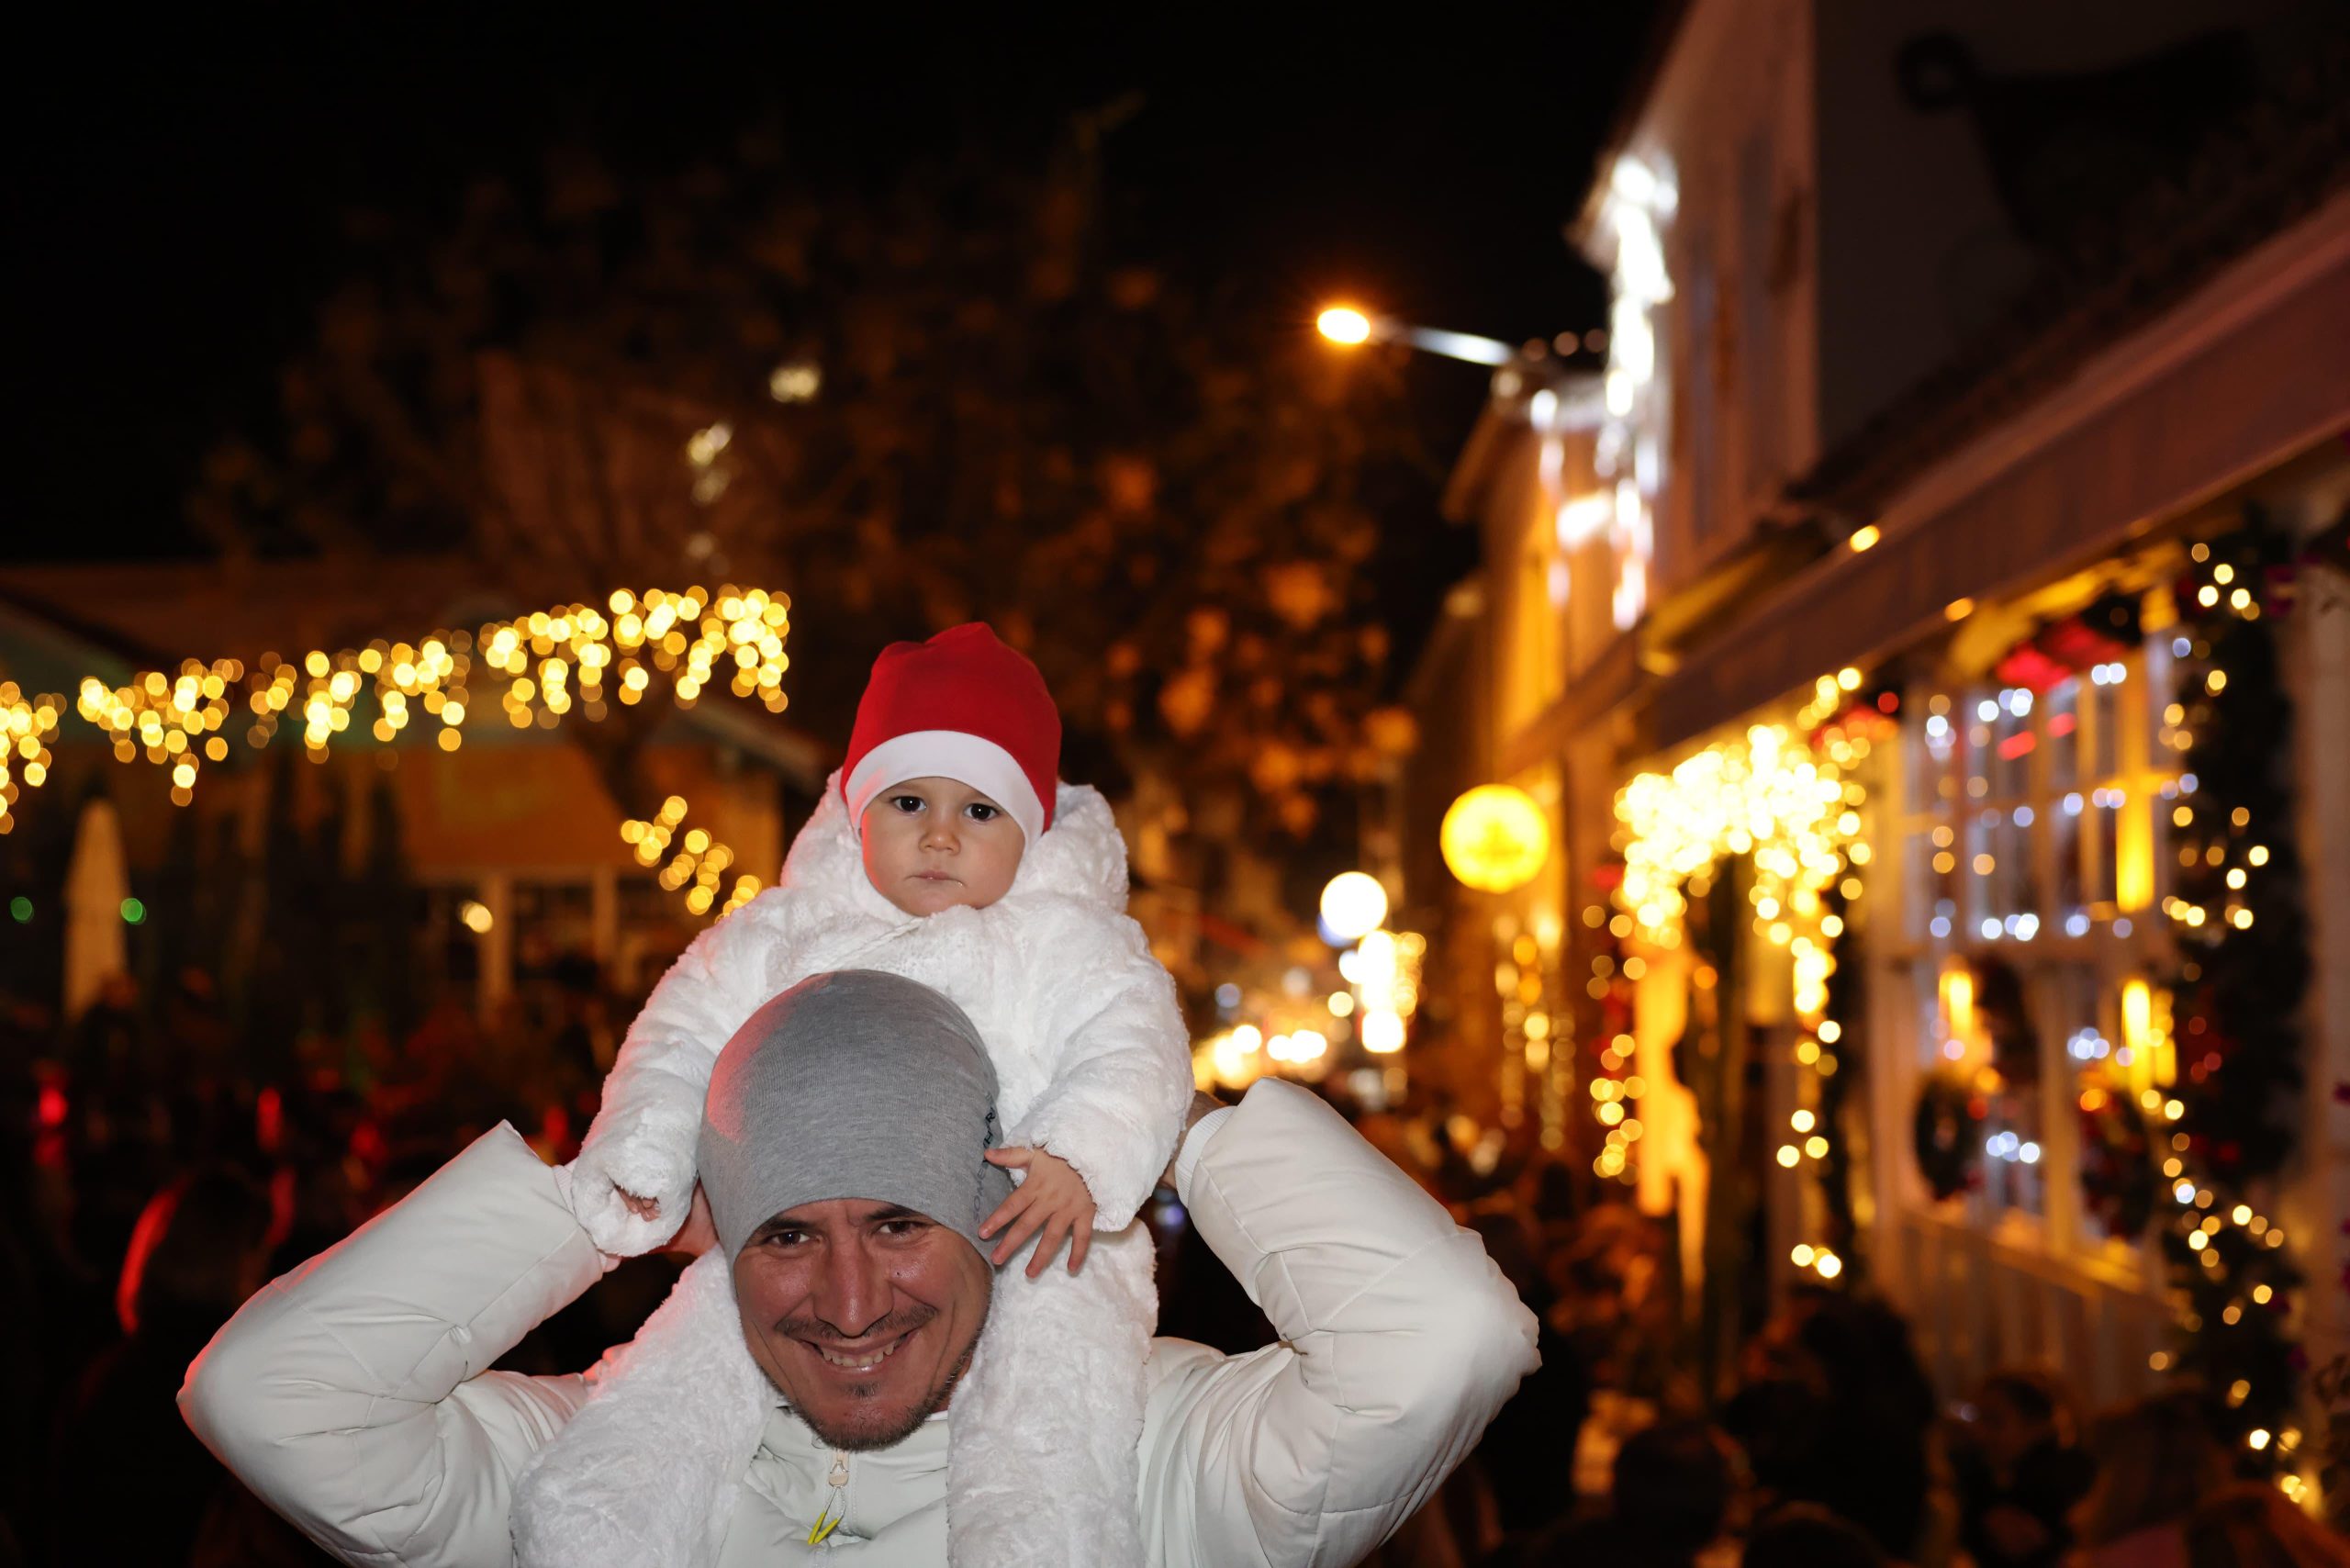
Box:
left=512, top=780, right=1192, bottom=1568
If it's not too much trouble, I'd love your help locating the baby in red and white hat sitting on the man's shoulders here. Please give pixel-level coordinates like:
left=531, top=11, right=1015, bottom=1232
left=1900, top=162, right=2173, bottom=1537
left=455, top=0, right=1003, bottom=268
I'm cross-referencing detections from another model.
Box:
left=512, top=625, right=1192, bottom=1568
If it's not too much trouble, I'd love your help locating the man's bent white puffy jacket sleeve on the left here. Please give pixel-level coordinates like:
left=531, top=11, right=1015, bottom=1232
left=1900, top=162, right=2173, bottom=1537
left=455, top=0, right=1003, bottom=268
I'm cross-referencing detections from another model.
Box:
left=179, top=1124, right=604, bottom=1568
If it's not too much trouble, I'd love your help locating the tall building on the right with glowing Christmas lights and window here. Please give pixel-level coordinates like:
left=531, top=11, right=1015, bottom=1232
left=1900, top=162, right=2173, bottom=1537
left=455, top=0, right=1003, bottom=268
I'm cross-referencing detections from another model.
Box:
left=1413, top=0, right=2350, bottom=1490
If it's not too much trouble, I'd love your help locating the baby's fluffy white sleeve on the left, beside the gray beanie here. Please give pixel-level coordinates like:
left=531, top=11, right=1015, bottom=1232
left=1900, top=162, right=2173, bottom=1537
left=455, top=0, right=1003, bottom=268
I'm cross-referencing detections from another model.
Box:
left=571, top=889, right=794, bottom=1258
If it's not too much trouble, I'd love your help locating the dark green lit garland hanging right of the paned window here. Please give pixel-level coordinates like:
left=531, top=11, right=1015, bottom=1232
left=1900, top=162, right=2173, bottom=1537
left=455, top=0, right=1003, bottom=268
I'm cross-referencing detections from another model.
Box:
left=2157, top=520, right=2310, bottom=1472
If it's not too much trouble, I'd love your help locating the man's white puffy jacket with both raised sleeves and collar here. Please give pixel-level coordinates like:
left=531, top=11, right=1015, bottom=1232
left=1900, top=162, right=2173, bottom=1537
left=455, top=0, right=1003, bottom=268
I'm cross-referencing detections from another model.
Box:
left=181, top=1081, right=1535, bottom=1568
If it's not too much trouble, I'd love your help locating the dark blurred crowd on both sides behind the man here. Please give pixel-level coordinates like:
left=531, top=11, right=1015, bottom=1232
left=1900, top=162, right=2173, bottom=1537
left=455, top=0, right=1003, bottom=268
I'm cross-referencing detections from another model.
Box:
left=0, top=959, right=2350, bottom=1568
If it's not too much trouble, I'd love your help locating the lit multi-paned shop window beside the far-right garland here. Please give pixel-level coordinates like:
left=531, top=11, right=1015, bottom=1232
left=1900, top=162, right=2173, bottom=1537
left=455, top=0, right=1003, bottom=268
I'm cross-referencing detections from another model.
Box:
left=1894, top=640, right=2195, bottom=1246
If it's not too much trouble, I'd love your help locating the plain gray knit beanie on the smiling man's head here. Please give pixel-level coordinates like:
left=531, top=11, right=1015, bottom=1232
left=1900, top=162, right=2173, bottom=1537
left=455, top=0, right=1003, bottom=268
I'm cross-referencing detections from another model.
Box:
left=698, top=969, right=1013, bottom=1258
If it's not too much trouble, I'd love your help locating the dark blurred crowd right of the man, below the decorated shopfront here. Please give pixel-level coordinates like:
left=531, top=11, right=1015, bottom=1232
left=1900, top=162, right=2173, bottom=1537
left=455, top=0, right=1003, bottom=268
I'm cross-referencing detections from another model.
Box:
left=1269, top=1105, right=2350, bottom=1568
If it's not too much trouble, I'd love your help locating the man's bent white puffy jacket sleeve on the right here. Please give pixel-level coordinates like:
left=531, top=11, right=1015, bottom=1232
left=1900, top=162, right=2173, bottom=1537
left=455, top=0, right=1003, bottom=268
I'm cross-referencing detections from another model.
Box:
left=1142, top=1079, right=1537, bottom=1568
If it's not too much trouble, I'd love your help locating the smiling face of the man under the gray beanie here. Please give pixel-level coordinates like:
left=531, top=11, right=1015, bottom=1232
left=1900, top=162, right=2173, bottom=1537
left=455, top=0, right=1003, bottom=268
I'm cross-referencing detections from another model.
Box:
left=733, top=1204, right=991, bottom=1450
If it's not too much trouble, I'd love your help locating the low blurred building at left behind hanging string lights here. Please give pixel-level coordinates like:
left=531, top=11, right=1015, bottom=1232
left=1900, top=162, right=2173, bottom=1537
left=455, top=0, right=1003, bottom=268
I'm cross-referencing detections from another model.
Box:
left=0, top=559, right=827, bottom=1030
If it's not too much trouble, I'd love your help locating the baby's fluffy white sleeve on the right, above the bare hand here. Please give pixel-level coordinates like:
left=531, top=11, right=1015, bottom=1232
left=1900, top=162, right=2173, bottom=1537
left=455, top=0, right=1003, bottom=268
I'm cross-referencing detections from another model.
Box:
left=1013, top=913, right=1192, bottom=1229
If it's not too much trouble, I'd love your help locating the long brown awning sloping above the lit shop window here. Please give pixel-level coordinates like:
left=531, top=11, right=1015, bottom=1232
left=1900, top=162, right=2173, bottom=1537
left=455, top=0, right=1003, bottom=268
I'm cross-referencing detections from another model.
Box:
left=1648, top=193, right=2350, bottom=750
